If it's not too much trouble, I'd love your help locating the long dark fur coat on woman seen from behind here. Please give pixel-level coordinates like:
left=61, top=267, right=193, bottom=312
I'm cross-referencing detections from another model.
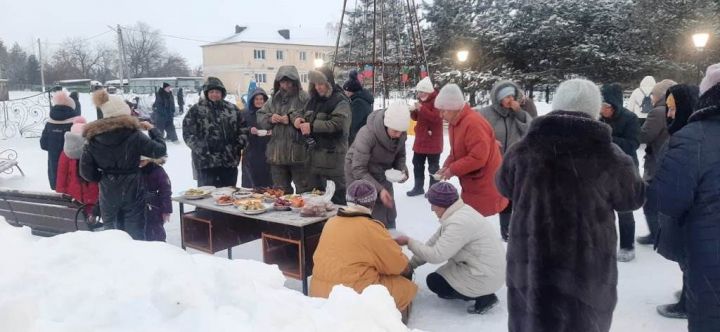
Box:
left=497, top=111, right=645, bottom=332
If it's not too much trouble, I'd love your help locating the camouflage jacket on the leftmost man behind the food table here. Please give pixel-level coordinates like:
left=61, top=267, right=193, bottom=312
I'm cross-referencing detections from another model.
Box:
left=183, top=99, right=248, bottom=169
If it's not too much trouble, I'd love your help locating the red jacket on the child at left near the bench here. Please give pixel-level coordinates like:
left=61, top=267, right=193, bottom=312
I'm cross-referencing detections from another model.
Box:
left=55, top=151, right=99, bottom=213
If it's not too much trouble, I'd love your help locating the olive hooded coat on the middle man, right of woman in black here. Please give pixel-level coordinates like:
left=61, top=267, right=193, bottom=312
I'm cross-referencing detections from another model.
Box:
left=257, top=66, right=310, bottom=166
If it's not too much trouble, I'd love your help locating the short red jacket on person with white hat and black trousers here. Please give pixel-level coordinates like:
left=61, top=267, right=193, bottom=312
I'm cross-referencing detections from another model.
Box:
left=410, top=91, right=443, bottom=154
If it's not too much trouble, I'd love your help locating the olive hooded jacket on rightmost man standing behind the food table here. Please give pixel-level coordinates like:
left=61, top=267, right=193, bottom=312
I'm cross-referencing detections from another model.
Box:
left=300, top=70, right=350, bottom=176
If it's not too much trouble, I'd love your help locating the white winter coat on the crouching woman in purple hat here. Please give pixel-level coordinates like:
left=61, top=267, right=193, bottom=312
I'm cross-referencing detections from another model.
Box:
left=408, top=199, right=506, bottom=297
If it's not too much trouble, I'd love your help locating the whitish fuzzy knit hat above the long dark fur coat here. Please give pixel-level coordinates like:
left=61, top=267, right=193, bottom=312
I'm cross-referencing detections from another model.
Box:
left=552, top=78, right=602, bottom=119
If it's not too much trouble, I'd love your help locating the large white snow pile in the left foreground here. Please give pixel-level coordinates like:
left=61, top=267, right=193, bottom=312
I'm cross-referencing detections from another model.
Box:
left=0, top=218, right=416, bottom=331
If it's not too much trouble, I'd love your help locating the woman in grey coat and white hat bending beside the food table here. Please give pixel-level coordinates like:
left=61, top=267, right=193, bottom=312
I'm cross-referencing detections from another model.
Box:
left=345, top=101, right=410, bottom=229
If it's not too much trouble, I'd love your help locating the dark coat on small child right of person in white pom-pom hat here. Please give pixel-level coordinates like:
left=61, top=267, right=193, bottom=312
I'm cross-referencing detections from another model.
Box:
left=140, top=162, right=172, bottom=241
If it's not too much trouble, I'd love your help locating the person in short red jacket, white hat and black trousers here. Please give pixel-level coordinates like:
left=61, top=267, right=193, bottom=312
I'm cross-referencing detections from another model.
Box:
left=407, top=77, right=443, bottom=197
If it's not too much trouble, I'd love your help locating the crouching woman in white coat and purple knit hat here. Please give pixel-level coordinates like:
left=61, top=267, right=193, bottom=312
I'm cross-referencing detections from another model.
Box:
left=395, top=182, right=505, bottom=314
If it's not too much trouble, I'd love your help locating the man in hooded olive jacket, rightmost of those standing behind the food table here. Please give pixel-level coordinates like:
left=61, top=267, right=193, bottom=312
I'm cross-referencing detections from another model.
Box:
left=291, top=67, right=351, bottom=205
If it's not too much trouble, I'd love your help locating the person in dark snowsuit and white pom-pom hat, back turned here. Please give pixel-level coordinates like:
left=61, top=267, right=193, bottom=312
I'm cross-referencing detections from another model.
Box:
left=80, top=90, right=167, bottom=240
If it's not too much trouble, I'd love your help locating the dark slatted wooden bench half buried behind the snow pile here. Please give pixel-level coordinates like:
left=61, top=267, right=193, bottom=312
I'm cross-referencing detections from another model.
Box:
left=0, top=188, right=90, bottom=236
